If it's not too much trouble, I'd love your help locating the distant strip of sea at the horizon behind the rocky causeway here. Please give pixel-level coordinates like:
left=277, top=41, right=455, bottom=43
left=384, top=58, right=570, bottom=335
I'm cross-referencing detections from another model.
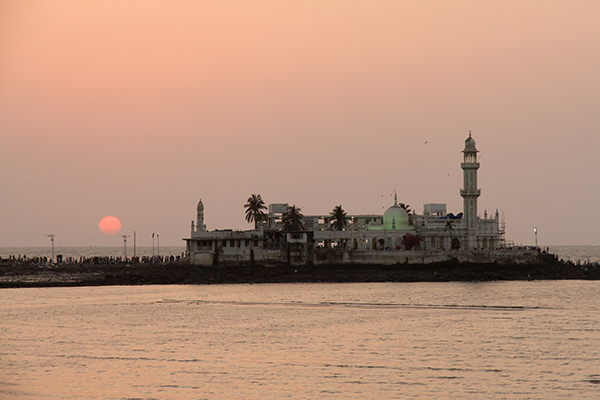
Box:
left=0, top=246, right=600, bottom=263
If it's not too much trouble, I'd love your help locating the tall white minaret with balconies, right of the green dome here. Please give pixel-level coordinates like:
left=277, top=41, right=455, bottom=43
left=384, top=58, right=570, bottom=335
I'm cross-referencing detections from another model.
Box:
left=460, top=131, right=481, bottom=250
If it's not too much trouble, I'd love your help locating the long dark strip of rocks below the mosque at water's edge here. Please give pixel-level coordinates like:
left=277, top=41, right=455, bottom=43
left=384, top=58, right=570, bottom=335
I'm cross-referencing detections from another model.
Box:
left=0, top=261, right=600, bottom=288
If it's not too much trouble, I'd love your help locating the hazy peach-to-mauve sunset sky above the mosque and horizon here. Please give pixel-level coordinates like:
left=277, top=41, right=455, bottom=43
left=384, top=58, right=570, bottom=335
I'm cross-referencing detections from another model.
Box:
left=0, top=0, right=600, bottom=247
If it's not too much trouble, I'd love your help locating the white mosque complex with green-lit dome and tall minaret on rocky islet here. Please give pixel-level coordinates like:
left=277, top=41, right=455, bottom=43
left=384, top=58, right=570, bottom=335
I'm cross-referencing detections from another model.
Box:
left=184, top=132, right=516, bottom=265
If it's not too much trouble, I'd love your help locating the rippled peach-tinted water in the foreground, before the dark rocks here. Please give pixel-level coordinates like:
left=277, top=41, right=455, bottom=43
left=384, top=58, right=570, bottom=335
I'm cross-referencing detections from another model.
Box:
left=0, top=281, right=600, bottom=399
